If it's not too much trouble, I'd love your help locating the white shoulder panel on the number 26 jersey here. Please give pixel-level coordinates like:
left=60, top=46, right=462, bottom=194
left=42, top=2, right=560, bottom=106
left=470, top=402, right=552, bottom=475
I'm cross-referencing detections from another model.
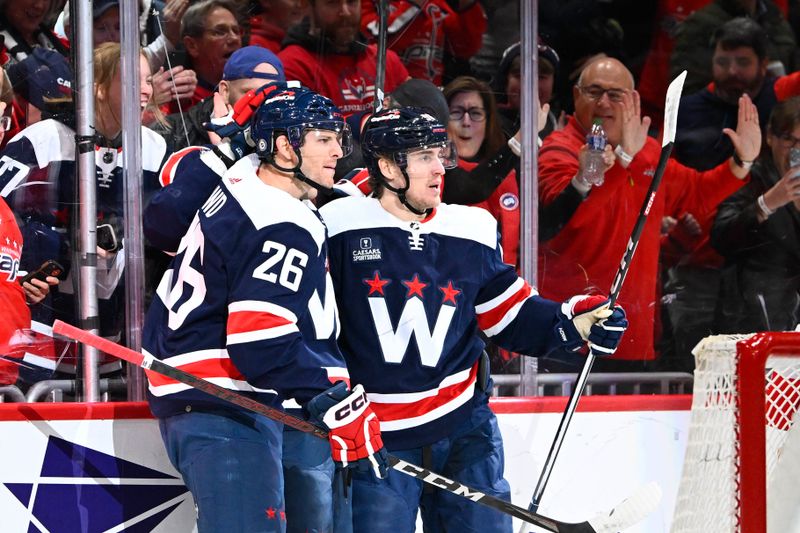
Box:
left=222, top=154, right=325, bottom=253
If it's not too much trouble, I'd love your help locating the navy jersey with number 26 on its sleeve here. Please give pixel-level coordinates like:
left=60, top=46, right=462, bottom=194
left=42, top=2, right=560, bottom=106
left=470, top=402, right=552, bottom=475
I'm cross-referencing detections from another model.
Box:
left=143, top=155, right=348, bottom=417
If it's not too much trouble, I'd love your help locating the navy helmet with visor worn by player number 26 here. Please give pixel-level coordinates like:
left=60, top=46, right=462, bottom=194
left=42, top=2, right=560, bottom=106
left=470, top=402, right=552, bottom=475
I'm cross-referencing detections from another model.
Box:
left=250, top=82, right=353, bottom=193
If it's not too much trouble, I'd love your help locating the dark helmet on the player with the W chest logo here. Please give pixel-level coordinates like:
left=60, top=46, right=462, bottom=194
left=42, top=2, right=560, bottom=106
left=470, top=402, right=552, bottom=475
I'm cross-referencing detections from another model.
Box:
left=361, top=107, right=457, bottom=215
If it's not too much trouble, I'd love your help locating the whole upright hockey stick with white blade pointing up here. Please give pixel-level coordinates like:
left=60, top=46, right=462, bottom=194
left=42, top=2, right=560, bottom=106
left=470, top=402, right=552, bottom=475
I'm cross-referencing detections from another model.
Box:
left=528, top=71, right=686, bottom=512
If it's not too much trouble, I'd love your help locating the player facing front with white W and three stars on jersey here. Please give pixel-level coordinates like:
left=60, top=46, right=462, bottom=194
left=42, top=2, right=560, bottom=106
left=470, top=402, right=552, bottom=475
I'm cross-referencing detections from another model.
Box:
left=321, top=108, right=627, bottom=533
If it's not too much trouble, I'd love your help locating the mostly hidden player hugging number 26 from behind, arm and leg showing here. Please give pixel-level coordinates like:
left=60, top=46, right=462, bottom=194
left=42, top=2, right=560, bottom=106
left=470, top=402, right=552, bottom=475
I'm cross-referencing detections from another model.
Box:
left=144, top=79, right=358, bottom=533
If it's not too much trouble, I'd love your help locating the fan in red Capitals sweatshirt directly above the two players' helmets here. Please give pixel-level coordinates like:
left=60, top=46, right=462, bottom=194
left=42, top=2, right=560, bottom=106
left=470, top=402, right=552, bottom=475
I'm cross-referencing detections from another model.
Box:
left=278, top=2, right=409, bottom=115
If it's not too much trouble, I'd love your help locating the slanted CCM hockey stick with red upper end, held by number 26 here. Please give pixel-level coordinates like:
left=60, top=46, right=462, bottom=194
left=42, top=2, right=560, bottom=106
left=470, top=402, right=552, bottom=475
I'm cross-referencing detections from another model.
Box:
left=53, top=320, right=661, bottom=533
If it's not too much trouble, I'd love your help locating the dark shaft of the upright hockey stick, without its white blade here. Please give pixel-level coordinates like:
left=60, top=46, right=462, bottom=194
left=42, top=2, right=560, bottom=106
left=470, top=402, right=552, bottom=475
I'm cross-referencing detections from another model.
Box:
left=528, top=142, right=674, bottom=512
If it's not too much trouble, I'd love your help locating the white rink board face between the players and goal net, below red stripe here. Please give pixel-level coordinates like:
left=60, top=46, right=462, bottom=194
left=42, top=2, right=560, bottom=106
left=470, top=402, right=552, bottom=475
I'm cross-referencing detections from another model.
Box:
left=506, top=411, right=689, bottom=533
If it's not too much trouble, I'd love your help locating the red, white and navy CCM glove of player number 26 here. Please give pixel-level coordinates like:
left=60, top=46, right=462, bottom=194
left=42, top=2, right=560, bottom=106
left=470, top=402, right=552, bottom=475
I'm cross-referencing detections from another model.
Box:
left=306, top=381, right=388, bottom=478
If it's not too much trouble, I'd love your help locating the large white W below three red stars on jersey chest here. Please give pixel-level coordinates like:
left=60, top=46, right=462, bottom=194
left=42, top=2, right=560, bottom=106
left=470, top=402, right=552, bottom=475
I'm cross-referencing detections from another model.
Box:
left=367, top=297, right=456, bottom=367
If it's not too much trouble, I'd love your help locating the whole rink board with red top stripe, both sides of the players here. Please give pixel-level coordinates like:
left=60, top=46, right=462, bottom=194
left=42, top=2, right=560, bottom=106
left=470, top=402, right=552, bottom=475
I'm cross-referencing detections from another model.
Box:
left=0, top=396, right=691, bottom=533
